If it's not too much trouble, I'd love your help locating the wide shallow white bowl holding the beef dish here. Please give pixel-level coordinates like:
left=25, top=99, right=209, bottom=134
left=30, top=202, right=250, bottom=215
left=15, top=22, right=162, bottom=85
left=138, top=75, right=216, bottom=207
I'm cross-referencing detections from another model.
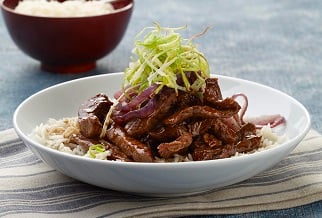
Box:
left=13, top=73, right=310, bottom=196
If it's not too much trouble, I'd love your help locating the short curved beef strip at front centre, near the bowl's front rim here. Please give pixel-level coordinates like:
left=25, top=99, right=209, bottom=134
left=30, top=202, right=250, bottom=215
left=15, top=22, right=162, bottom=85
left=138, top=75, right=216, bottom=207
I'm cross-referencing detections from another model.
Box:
left=158, top=133, right=192, bottom=158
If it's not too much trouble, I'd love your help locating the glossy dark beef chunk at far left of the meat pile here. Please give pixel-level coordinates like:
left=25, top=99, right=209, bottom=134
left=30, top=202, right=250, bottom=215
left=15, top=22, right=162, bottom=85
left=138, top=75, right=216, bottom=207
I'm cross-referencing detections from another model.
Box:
left=78, top=94, right=113, bottom=138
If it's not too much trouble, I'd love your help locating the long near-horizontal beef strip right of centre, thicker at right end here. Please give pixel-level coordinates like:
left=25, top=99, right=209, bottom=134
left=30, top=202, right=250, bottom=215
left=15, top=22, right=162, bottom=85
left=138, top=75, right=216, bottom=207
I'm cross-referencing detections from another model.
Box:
left=163, top=99, right=240, bottom=125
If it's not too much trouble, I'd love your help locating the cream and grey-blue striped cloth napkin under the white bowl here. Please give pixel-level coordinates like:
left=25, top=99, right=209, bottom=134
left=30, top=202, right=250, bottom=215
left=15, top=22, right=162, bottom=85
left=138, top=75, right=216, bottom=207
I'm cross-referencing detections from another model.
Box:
left=0, top=129, right=322, bottom=218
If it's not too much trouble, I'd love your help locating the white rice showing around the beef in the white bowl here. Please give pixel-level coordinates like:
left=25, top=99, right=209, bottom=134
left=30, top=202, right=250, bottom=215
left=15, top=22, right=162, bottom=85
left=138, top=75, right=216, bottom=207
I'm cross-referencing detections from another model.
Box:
left=30, top=117, right=287, bottom=162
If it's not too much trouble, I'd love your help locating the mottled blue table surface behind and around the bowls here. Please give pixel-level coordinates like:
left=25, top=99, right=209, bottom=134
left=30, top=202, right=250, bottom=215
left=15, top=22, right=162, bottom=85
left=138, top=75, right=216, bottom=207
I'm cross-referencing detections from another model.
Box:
left=0, top=0, right=322, bottom=217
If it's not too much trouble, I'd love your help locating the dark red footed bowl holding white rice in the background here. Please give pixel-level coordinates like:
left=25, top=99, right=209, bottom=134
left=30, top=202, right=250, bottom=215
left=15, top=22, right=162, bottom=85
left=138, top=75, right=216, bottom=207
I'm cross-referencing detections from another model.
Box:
left=1, top=0, right=134, bottom=73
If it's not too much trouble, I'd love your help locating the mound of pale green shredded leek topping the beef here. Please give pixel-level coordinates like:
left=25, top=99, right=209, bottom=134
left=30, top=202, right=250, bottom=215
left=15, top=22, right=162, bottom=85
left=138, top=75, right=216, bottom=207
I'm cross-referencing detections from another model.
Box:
left=123, top=23, right=210, bottom=92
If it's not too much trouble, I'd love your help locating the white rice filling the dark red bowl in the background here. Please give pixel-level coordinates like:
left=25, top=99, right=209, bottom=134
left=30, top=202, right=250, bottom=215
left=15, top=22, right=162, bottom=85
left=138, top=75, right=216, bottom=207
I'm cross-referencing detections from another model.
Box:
left=15, top=0, right=114, bottom=17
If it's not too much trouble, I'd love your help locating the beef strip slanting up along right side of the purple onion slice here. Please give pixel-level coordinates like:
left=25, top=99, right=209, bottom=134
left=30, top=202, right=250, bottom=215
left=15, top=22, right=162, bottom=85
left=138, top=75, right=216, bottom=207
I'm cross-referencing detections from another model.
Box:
left=125, top=88, right=177, bottom=137
